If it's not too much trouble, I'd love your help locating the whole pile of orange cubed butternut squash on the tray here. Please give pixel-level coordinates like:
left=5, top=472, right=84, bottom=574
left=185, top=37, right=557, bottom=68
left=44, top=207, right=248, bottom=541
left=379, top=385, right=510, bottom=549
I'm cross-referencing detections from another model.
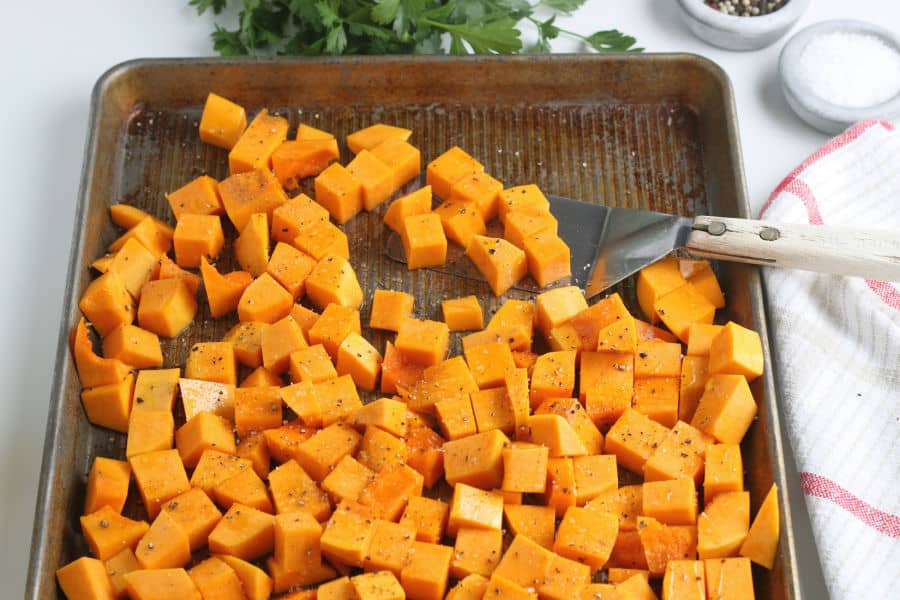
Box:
left=57, top=94, right=779, bottom=600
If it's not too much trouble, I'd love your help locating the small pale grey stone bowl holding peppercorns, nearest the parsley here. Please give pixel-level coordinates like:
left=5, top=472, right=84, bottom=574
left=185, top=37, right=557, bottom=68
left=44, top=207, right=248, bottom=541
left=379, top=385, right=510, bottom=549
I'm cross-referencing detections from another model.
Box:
left=678, top=0, right=809, bottom=50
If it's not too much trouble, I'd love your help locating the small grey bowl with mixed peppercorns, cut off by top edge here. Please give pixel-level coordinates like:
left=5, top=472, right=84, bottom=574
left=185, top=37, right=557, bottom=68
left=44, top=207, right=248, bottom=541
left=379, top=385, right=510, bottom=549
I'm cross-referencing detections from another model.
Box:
left=678, top=0, right=809, bottom=50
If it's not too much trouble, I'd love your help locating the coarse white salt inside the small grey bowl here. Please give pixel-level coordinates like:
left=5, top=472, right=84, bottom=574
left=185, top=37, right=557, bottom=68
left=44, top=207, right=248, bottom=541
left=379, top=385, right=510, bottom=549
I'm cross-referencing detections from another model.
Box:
left=799, top=31, right=900, bottom=108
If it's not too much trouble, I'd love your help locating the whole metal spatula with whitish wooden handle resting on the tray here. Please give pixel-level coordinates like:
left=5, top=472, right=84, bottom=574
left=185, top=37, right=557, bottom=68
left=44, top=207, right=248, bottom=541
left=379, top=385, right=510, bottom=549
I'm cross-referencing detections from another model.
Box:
left=548, top=196, right=900, bottom=298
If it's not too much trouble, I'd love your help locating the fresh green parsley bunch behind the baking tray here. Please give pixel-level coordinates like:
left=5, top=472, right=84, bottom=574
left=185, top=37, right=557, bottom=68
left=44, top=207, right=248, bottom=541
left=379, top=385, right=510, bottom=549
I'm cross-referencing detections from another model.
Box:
left=190, top=0, right=642, bottom=56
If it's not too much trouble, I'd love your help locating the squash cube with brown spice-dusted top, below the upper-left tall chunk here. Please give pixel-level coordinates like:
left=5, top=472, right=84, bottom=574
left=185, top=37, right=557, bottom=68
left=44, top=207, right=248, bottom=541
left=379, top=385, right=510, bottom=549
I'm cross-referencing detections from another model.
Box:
left=219, top=168, right=288, bottom=231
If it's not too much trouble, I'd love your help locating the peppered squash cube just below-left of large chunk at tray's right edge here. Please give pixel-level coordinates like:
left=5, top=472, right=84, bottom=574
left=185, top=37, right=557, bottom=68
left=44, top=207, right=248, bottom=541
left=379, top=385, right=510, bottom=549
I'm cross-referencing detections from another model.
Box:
left=644, top=421, right=712, bottom=484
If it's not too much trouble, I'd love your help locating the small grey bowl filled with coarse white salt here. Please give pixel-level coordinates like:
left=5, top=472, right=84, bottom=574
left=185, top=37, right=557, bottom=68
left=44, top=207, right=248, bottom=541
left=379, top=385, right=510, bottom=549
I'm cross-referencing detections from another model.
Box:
left=779, top=20, right=900, bottom=134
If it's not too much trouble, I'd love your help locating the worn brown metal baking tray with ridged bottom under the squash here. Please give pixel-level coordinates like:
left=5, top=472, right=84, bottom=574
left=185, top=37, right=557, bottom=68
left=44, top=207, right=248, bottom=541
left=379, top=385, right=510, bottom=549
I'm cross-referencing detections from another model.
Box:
left=26, top=54, right=800, bottom=600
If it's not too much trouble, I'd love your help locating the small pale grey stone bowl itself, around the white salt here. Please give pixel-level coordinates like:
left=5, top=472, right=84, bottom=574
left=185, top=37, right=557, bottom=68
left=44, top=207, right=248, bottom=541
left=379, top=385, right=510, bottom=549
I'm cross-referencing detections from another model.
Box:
left=778, top=19, right=900, bottom=134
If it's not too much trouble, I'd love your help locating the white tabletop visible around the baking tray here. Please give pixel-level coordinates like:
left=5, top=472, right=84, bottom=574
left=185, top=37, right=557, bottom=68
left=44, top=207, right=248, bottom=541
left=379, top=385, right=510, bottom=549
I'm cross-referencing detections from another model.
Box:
left=0, top=0, right=900, bottom=598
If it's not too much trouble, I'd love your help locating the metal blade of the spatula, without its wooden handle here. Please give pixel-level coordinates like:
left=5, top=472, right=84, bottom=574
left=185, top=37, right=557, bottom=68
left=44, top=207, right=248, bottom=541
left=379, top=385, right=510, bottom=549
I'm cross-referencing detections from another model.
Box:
left=547, top=196, right=692, bottom=299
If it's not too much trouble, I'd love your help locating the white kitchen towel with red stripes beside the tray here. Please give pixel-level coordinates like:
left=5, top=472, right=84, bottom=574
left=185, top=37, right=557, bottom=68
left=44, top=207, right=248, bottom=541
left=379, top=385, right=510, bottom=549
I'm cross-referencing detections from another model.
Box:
left=760, top=121, right=900, bottom=600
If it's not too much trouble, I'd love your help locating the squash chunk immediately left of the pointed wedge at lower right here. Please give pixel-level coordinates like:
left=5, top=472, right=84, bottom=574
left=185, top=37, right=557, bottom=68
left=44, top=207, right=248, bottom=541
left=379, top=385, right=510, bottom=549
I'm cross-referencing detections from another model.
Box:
left=697, top=492, right=750, bottom=558
